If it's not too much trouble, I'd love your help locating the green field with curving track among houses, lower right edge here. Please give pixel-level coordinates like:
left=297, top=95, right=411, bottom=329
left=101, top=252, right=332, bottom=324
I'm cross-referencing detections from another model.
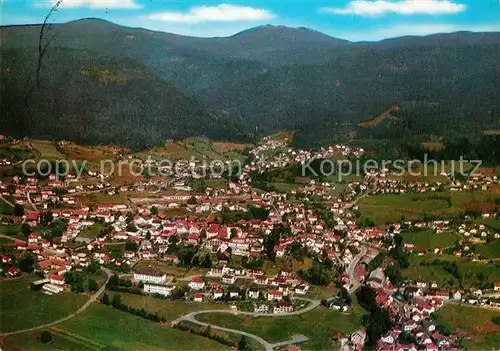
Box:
left=402, top=254, right=500, bottom=288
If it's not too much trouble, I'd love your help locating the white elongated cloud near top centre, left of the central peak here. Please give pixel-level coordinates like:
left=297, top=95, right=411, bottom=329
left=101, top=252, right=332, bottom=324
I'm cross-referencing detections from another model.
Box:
left=145, top=4, right=276, bottom=23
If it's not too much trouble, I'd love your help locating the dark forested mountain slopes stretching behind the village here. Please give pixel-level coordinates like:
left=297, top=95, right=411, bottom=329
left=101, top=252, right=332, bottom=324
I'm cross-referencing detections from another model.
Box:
left=0, top=19, right=500, bottom=154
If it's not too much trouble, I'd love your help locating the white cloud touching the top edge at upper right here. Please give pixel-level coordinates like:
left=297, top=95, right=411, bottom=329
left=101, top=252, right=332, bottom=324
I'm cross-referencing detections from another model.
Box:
left=321, top=0, right=466, bottom=17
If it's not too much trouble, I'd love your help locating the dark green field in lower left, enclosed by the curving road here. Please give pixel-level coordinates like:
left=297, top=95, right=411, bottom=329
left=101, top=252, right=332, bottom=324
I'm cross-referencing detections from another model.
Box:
left=0, top=276, right=88, bottom=332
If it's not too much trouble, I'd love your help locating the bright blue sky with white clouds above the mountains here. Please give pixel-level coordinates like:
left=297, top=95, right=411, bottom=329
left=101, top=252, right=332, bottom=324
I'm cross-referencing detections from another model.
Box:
left=0, top=0, right=500, bottom=41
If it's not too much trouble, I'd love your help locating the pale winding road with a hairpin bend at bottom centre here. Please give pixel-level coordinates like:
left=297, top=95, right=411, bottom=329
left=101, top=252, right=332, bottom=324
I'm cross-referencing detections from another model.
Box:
left=174, top=299, right=321, bottom=350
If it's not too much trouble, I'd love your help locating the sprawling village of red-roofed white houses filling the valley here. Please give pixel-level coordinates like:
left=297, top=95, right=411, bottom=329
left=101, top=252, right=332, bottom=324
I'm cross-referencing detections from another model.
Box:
left=0, top=138, right=500, bottom=351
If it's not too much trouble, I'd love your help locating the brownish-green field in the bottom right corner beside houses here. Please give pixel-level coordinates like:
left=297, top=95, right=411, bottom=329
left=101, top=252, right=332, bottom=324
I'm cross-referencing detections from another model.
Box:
left=436, top=305, right=500, bottom=350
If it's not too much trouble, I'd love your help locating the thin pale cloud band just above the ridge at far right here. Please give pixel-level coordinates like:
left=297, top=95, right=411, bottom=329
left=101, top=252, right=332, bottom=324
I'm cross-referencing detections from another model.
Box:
left=328, top=23, right=500, bottom=41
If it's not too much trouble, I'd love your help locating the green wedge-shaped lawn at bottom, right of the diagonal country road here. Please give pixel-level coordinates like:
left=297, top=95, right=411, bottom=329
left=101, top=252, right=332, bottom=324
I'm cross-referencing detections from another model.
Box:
left=57, top=304, right=227, bottom=350
